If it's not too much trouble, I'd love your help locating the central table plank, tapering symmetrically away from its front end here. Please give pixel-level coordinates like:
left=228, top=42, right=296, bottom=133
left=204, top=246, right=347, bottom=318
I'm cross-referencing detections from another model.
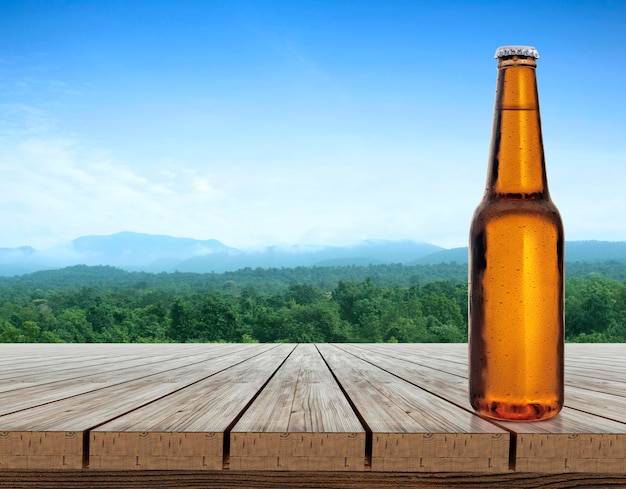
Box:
left=230, top=344, right=365, bottom=471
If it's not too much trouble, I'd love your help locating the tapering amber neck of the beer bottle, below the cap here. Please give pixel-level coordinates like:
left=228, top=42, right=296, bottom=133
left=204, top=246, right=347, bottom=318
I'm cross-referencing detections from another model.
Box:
left=487, top=56, right=548, bottom=199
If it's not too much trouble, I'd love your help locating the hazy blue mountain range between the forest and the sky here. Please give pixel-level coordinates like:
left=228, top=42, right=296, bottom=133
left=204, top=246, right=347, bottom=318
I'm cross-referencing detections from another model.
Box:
left=0, top=232, right=626, bottom=276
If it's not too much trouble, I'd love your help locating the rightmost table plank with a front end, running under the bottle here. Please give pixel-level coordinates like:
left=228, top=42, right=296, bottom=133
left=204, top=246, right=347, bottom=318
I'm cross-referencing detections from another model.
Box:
left=346, top=345, right=626, bottom=473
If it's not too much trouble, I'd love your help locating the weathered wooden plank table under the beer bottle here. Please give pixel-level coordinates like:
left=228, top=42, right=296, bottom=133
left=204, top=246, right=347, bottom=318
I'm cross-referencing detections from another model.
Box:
left=0, top=344, right=626, bottom=488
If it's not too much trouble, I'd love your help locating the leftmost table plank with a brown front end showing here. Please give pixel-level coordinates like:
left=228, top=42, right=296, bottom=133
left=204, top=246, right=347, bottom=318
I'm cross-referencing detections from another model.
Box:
left=0, top=345, right=273, bottom=469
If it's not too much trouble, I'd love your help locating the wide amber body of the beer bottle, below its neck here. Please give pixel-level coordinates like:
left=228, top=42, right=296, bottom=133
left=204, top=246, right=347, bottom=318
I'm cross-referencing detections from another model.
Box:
left=470, top=201, right=563, bottom=421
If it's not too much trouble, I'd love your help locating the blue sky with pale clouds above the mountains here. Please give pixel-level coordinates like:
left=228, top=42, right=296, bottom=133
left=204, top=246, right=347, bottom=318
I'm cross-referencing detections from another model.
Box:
left=0, top=0, right=626, bottom=248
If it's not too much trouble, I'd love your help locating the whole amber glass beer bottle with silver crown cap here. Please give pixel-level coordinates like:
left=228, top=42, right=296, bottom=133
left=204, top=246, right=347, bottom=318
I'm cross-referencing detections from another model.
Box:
left=469, top=46, right=564, bottom=421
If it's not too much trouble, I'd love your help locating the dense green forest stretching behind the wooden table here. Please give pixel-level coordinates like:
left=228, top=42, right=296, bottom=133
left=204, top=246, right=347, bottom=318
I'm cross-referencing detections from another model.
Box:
left=0, top=262, right=626, bottom=343
